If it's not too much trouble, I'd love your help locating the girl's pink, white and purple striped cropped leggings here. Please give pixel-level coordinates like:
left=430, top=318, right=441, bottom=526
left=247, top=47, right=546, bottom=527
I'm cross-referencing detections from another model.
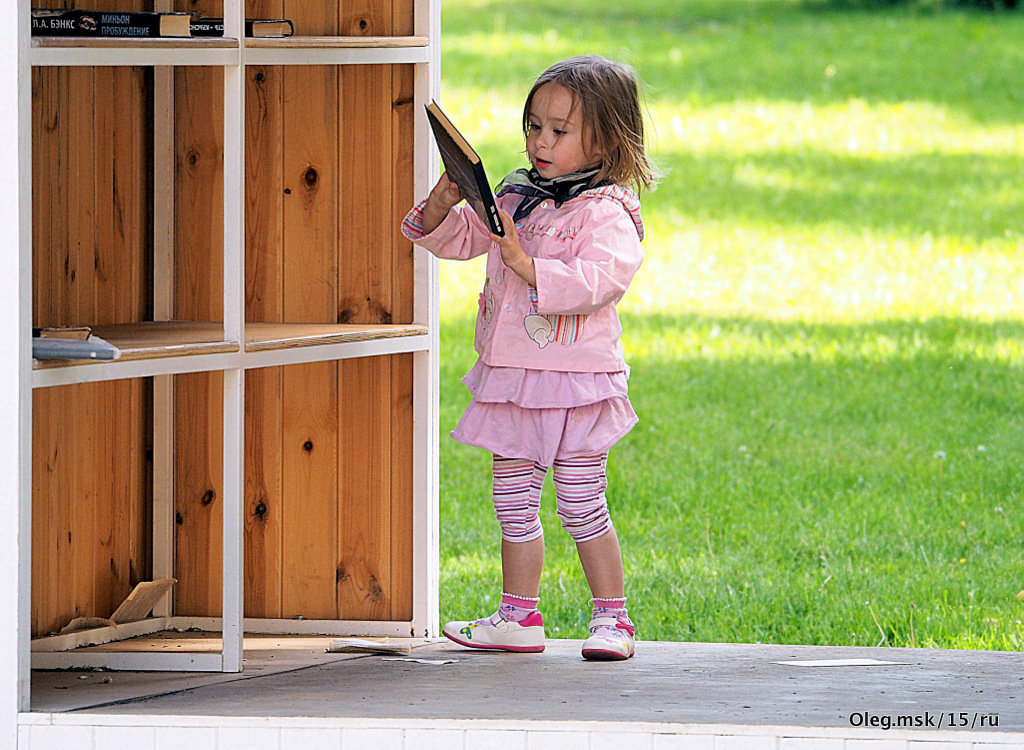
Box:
left=493, top=453, right=611, bottom=542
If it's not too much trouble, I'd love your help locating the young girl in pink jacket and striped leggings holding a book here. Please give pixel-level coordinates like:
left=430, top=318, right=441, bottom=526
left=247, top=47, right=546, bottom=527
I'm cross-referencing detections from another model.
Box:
left=402, top=56, right=656, bottom=660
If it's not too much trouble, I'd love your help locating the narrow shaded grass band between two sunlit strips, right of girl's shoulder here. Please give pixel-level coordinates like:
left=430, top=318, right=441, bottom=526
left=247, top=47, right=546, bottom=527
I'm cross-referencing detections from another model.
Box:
left=644, top=149, right=1024, bottom=241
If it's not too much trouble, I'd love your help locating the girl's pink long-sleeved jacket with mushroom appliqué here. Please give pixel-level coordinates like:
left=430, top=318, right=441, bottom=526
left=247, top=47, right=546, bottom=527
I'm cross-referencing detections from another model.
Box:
left=402, top=185, right=643, bottom=372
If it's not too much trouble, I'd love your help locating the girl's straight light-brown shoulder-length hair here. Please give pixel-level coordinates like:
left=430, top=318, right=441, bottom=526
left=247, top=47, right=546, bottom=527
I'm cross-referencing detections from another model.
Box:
left=522, top=55, right=660, bottom=192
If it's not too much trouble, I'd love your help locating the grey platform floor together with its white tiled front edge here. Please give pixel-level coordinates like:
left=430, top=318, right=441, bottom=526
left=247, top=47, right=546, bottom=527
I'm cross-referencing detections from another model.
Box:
left=19, top=638, right=1024, bottom=750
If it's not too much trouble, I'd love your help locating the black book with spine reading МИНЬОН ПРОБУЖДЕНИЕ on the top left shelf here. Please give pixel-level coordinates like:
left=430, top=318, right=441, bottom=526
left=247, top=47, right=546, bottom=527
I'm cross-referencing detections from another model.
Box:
left=32, top=8, right=191, bottom=39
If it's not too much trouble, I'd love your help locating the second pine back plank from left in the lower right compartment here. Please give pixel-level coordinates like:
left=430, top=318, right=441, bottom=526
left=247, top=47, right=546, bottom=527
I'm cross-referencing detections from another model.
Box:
left=282, top=362, right=338, bottom=619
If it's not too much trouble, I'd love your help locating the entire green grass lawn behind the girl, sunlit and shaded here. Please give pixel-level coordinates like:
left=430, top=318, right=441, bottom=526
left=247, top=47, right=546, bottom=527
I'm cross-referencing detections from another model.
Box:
left=440, top=0, right=1024, bottom=651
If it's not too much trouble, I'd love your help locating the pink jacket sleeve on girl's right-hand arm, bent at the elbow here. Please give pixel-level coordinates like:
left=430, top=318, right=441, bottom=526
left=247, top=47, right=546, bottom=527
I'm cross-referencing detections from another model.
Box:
left=531, top=201, right=643, bottom=315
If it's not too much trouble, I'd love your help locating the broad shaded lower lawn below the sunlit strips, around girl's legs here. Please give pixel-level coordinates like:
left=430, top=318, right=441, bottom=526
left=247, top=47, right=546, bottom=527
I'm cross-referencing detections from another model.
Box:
left=441, top=315, right=1024, bottom=649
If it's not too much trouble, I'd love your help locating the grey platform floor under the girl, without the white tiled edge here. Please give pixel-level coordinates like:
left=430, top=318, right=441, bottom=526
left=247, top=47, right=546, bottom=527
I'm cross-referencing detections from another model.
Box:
left=34, top=640, right=1024, bottom=741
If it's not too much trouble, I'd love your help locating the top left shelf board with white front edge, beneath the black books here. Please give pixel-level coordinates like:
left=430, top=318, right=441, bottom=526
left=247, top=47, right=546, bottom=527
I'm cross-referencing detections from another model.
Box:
left=30, top=37, right=241, bottom=67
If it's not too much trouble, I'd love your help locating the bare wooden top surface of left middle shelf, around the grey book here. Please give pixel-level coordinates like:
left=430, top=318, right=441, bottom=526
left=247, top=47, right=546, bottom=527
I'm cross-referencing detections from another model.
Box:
left=33, top=321, right=239, bottom=370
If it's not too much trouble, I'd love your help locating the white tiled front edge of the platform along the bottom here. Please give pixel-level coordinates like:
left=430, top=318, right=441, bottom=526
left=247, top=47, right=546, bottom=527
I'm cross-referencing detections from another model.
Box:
left=18, top=713, right=1024, bottom=750
